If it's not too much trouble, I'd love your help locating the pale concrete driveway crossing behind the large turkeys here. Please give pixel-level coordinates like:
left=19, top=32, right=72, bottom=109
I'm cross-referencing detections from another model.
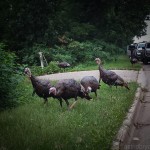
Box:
left=38, top=70, right=139, bottom=82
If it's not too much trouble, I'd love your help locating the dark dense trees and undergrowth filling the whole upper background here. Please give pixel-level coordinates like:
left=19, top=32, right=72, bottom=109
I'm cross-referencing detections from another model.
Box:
left=0, top=0, right=150, bottom=65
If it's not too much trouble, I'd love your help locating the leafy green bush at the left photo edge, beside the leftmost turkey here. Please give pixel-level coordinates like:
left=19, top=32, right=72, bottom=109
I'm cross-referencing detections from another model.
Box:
left=0, top=43, right=20, bottom=108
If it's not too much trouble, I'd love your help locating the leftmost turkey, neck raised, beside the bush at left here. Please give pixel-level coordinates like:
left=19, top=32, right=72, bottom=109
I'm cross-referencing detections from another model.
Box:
left=24, top=68, right=54, bottom=104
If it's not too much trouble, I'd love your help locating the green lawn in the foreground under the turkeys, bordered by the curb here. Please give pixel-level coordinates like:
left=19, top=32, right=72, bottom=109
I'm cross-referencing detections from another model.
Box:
left=0, top=80, right=138, bottom=150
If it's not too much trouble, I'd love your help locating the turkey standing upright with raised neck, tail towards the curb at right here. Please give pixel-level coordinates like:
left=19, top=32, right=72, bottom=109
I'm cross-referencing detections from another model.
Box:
left=95, top=58, right=130, bottom=90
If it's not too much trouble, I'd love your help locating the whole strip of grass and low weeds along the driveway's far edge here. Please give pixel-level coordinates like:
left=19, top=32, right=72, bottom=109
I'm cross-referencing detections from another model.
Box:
left=31, top=55, right=142, bottom=75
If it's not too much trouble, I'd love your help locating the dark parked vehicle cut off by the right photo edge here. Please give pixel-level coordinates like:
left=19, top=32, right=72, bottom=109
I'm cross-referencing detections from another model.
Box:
left=141, top=42, right=150, bottom=64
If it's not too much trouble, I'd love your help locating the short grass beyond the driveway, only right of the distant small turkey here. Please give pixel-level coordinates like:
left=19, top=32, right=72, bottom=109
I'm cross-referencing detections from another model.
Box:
left=67, top=55, right=141, bottom=71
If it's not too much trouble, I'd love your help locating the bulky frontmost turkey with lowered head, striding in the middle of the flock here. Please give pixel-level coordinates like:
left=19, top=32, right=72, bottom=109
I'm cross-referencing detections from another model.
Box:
left=49, top=79, right=91, bottom=109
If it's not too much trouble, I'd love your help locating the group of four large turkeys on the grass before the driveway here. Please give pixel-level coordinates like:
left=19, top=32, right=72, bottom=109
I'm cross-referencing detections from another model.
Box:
left=24, top=58, right=129, bottom=109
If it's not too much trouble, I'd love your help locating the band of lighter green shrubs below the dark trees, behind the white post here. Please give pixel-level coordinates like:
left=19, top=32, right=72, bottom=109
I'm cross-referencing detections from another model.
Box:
left=22, top=40, right=123, bottom=66
